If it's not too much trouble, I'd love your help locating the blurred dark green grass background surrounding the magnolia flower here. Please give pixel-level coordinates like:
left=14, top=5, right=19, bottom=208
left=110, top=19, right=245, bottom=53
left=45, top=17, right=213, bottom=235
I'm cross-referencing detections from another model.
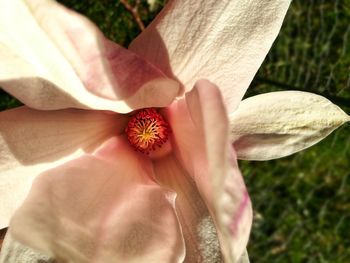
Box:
left=0, top=0, right=350, bottom=263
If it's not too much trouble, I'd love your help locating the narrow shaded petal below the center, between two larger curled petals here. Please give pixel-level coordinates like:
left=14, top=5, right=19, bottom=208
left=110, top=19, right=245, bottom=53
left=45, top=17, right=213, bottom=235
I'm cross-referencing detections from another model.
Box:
left=154, top=154, right=222, bottom=263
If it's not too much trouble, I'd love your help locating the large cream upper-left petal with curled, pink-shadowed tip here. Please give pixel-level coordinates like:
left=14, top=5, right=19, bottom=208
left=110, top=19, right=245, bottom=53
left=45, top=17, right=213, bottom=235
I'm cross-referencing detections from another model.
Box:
left=0, top=0, right=179, bottom=113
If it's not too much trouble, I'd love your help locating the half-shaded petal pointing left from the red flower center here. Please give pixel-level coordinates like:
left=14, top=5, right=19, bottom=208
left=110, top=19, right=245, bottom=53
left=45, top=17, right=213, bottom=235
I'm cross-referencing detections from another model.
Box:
left=0, top=107, right=125, bottom=228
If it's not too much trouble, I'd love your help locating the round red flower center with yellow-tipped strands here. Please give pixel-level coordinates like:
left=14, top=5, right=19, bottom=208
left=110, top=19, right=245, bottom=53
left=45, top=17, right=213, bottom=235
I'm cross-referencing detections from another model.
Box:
left=125, top=108, right=170, bottom=154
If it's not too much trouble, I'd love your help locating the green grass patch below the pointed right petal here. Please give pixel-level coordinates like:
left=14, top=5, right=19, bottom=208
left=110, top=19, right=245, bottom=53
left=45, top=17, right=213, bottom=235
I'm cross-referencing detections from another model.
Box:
left=240, top=126, right=350, bottom=263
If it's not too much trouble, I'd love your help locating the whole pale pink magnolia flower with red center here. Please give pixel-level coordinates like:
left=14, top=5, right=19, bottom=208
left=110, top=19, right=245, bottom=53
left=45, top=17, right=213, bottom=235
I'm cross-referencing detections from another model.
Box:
left=0, top=0, right=349, bottom=263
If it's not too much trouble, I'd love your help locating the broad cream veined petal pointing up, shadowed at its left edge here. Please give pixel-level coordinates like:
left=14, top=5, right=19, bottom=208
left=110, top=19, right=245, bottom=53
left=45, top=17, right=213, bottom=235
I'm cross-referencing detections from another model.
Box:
left=130, top=0, right=290, bottom=112
